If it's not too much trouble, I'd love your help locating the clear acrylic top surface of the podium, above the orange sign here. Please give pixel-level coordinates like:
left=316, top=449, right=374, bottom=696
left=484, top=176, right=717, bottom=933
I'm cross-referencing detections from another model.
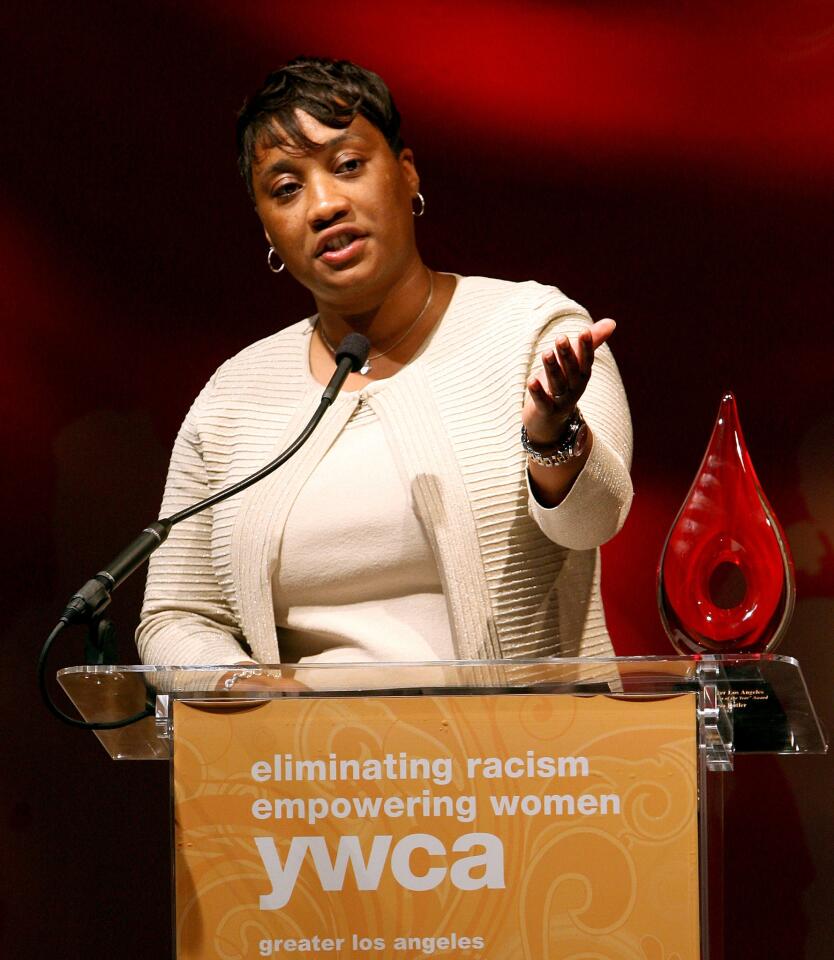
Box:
left=58, top=654, right=827, bottom=759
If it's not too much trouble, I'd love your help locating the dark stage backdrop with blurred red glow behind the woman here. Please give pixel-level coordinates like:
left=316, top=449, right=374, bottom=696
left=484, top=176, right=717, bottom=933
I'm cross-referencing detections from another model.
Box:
left=0, top=0, right=834, bottom=960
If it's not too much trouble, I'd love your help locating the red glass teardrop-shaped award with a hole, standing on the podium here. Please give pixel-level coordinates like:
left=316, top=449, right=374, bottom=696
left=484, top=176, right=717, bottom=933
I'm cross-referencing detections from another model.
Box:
left=657, top=393, right=795, bottom=654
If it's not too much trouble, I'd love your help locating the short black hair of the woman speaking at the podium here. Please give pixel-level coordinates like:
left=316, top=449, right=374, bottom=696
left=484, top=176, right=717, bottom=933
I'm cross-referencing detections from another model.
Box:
left=237, top=57, right=404, bottom=197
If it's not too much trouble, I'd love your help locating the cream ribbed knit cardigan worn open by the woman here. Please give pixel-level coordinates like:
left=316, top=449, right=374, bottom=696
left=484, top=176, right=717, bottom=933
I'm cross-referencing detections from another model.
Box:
left=137, top=277, right=631, bottom=665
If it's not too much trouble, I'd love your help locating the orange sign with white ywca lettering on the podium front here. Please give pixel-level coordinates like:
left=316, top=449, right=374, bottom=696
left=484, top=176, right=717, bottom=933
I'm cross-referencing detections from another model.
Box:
left=174, top=694, right=700, bottom=960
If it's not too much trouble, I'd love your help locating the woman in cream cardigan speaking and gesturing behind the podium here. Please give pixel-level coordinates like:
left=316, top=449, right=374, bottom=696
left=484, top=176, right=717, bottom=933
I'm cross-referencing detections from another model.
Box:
left=137, top=58, right=631, bottom=676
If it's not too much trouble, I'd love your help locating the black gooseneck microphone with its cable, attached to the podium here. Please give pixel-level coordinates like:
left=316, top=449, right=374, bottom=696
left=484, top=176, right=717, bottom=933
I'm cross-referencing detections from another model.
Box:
left=38, top=333, right=370, bottom=730
